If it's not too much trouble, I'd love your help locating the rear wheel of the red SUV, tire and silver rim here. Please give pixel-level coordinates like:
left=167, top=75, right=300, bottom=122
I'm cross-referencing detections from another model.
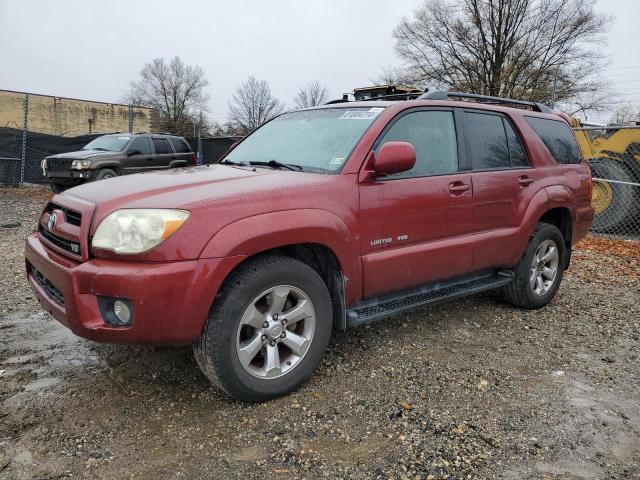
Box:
left=502, top=223, right=567, bottom=309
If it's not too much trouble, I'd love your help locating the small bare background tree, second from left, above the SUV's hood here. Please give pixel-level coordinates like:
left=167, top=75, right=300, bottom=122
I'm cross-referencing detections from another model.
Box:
left=229, top=77, right=284, bottom=134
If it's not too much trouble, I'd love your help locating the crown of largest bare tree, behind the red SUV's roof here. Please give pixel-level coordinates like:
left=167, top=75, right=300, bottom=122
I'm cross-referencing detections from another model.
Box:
left=393, top=0, right=610, bottom=109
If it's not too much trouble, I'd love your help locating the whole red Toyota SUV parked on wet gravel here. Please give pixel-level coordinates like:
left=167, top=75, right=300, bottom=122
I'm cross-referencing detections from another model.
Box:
left=25, top=92, right=593, bottom=401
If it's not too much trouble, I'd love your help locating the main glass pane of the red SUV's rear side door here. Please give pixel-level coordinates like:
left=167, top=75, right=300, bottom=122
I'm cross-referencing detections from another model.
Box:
left=465, top=112, right=511, bottom=170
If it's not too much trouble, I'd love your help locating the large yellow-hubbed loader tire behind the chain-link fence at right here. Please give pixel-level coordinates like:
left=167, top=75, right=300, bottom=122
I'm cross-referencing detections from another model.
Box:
left=589, top=159, right=640, bottom=233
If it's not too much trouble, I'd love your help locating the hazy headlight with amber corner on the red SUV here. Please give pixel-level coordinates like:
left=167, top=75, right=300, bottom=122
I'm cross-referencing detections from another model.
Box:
left=91, top=209, right=189, bottom=253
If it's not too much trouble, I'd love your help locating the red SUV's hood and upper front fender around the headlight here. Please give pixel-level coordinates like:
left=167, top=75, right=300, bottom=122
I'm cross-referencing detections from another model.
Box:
left=60, top=164, right=358, bottom=261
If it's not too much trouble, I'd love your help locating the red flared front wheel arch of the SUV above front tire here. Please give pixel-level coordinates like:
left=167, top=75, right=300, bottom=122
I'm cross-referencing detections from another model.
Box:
left=200, top=209, right=362, bottom=304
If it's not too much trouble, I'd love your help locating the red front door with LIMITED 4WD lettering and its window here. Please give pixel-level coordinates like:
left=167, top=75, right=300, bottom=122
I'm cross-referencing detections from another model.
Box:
left=359, top=108, right=473, bottom=298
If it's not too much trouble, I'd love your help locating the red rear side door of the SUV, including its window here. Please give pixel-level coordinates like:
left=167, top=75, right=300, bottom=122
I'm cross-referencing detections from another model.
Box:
left=464, top=110, right=539, bottom=270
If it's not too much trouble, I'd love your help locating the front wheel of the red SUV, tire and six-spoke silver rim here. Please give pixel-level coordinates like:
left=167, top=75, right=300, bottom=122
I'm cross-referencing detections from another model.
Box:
left=194, top=255, right=333, bottom=402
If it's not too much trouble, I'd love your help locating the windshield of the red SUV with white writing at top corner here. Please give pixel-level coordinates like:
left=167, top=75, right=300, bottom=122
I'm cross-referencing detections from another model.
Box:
left=223, top=107, right=384, bottom=172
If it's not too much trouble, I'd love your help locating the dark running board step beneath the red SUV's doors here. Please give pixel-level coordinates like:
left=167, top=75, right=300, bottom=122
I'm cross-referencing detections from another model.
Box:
left=347, top=270, right=513, bottom=327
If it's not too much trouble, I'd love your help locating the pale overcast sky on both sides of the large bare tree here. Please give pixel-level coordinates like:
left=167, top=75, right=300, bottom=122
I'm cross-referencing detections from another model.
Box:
left=0, top=0, right=640, bottom=121
